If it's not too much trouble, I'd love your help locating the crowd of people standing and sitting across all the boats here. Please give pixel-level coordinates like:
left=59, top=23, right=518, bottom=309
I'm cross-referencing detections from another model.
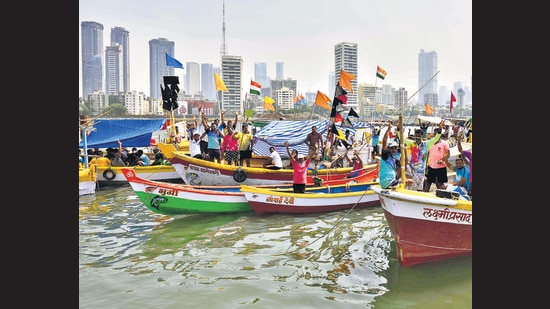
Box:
left=79, top=114, right=472, bottom=199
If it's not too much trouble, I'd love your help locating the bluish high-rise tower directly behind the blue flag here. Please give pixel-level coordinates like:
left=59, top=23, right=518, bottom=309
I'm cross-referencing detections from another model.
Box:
left=149, top=38, right=177, bottom=99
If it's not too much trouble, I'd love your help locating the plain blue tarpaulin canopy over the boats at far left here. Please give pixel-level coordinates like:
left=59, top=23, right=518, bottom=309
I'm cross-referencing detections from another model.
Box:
left=78, top=118, right=166, bottom=148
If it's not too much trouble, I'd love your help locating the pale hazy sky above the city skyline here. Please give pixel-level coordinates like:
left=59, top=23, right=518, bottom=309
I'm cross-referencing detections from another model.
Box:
left=75, top=0, right=472, bottom=101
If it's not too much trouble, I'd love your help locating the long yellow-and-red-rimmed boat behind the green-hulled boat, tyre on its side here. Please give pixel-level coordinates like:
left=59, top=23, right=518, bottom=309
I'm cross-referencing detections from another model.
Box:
left=157, top=143, right=377, bottom=186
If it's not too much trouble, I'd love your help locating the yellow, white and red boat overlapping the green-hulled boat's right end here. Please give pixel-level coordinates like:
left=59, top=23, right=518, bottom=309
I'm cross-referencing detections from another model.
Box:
left=241, top=182, right=380, bottom=214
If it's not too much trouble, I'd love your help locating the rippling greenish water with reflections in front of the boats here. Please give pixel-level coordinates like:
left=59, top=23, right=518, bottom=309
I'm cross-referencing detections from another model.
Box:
left=79, top=186, right=472, bottom=308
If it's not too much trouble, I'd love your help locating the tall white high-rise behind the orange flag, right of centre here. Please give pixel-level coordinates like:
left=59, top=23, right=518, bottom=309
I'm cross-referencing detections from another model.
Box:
left=334, top=42, right=358, bottom=110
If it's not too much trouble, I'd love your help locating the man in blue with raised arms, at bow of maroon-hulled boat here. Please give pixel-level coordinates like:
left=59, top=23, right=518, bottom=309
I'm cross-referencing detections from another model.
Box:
left=378, top=122, right=401, bottom=189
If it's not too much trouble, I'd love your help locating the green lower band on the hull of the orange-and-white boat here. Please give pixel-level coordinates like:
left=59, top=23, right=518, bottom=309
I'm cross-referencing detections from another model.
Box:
left=136, top=192, right=253, bottom=215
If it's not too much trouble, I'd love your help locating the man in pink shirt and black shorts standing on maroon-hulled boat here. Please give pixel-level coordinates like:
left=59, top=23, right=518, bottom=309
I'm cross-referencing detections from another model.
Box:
left=424, top=128, right=449, bottom=192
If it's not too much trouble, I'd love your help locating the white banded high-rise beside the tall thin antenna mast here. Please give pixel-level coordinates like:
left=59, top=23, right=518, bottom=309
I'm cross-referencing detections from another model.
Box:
left=220, top=55, right=243, bottom=115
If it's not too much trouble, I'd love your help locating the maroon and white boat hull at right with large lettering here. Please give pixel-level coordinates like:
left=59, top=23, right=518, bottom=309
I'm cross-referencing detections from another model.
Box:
left=373, top=186, right=472, bottom=267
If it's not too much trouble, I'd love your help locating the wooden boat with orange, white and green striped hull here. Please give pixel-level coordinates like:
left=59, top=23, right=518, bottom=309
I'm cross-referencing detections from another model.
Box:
left=121, top=168, right=377, bottom=215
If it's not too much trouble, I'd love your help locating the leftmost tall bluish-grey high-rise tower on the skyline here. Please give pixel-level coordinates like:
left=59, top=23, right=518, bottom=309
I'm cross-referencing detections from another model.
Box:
left=80, top=21, right=104, bottom=98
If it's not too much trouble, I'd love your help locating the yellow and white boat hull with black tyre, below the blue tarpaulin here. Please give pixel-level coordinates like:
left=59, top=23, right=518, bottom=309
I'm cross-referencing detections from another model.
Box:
left=97, top=165, right=183, bottom=186
